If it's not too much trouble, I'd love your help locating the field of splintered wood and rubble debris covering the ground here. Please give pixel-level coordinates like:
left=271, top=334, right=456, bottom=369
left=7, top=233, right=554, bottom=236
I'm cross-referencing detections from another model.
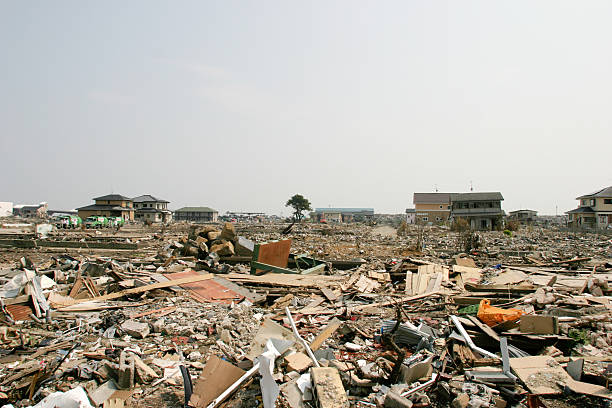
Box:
left=0, top=223, right=612, bottom=408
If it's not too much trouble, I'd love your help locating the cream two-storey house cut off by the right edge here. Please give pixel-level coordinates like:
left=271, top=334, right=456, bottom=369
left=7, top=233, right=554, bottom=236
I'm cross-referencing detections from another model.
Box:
left=566, top=186, right=612, bottom=229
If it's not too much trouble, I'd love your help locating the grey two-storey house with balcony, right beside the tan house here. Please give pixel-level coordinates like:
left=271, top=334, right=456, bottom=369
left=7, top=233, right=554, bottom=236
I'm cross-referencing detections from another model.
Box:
left=451, top=192, right=505, bottom=230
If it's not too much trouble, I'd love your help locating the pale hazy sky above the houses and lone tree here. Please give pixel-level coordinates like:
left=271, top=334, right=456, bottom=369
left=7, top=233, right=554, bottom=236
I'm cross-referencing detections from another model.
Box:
left=0, top=0, right=612, bottom=215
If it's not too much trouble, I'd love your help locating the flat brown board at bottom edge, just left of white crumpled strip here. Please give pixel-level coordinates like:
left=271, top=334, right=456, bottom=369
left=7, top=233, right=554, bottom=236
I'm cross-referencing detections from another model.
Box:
left=189, top=356, right=245, bottom=408
